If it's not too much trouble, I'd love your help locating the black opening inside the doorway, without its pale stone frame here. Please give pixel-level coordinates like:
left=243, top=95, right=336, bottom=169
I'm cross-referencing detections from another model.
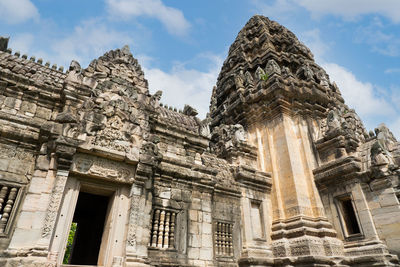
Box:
left=64, top=192, right=109, bottom=265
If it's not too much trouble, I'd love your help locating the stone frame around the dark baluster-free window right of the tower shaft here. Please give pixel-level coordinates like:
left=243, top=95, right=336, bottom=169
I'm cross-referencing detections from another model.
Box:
left=334, top=193, right=364, bottom=241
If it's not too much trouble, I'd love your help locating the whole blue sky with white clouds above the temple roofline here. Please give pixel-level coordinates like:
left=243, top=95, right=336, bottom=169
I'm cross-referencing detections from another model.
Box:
left=0, top=0, right=400, bottom=137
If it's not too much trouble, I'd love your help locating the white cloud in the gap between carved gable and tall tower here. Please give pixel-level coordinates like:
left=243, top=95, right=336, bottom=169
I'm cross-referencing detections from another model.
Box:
left=144, top=55, right=223, bottom=118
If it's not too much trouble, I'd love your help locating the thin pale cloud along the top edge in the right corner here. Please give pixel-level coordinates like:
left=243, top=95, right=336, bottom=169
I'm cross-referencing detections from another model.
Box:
left=296, top=0, right=400, bottom=23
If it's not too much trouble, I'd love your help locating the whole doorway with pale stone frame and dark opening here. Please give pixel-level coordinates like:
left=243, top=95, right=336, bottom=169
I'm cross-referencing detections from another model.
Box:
left=51, top=176, right=130, bottom=267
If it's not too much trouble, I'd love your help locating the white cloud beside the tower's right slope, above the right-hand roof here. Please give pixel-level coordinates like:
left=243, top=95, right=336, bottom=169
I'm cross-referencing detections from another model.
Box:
left=322, top=63, right=395, bottom=117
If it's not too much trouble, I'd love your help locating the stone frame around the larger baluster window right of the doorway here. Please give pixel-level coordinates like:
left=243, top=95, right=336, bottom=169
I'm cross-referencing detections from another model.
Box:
left=147, top=205, right=182, bottom=252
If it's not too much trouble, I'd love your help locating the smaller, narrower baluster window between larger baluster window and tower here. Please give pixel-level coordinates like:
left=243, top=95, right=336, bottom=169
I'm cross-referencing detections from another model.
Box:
left=214, top=222, right=233, bottom=257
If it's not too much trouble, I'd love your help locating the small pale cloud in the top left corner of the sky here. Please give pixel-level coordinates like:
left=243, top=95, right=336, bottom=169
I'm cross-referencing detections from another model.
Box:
left=0, top=0, right=39, bottom=24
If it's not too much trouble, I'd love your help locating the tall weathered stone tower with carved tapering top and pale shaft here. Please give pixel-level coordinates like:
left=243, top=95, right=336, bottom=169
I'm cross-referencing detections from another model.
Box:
left=210, top=16, right=400, bottom=266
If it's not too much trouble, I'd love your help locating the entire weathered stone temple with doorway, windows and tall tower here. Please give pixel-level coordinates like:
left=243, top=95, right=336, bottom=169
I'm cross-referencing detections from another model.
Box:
left=0, top=16, right=400, bottom=267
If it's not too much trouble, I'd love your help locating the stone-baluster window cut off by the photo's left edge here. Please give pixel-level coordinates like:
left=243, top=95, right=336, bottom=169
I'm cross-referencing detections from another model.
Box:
left=0, top=184, right=20, bottom=235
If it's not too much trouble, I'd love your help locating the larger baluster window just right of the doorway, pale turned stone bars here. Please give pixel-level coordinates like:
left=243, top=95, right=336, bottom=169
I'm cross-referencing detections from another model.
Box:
left=149, top=208, right=176, bottom=249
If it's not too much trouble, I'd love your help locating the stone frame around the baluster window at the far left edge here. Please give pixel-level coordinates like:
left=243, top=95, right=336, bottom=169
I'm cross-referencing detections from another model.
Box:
left=0, top=181, right=25, bottom=238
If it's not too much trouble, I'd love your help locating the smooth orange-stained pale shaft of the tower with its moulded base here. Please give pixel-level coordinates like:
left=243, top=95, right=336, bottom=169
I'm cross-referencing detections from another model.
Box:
left=249, top=112, right=343, bottom=262
